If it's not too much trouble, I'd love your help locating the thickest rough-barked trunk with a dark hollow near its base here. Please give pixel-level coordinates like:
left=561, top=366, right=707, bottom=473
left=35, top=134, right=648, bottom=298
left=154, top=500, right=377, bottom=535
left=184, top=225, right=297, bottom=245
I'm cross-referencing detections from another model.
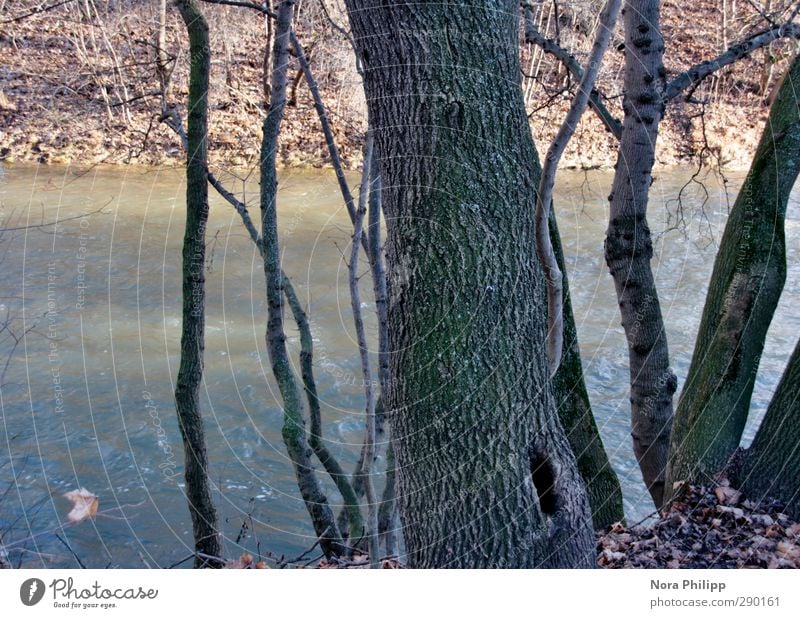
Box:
left=347, top=0, right=594, bottom=567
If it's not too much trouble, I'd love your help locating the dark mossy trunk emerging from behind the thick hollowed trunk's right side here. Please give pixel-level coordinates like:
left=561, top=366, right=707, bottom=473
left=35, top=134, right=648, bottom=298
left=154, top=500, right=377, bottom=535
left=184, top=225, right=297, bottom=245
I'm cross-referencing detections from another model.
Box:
left=549, top=209, right=625, bottom=530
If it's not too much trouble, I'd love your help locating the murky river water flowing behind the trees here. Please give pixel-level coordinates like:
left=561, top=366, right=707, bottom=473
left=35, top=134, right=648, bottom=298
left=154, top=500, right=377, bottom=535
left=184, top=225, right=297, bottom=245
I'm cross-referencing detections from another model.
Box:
left=0, top=161, right=800, bottom=567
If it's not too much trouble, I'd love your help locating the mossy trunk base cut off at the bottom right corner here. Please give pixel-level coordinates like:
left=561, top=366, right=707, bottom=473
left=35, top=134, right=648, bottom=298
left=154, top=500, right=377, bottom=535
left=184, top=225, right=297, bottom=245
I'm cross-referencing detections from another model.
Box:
left=732, top=334, right=800, bottom=519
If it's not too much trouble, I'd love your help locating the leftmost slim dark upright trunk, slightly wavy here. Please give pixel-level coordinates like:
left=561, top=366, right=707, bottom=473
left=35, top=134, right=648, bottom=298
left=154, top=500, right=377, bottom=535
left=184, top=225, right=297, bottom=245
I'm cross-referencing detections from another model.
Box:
left=175, top=0, right=222, bottom=567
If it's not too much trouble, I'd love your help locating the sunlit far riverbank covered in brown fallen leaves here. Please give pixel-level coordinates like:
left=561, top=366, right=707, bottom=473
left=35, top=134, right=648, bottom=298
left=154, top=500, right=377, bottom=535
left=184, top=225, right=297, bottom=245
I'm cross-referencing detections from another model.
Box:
left=0, top=0, right=794, bottom=169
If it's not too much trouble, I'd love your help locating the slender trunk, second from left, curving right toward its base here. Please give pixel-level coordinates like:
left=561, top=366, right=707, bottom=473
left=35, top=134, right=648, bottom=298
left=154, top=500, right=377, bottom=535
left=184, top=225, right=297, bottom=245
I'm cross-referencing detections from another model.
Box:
left=261, top=0, right=346, bottom=556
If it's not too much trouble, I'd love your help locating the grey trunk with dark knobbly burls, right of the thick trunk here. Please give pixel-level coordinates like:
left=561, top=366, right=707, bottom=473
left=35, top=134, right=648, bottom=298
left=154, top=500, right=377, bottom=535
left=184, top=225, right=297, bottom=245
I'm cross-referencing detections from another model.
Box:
left=605, top=0, right=678, bottom=506
